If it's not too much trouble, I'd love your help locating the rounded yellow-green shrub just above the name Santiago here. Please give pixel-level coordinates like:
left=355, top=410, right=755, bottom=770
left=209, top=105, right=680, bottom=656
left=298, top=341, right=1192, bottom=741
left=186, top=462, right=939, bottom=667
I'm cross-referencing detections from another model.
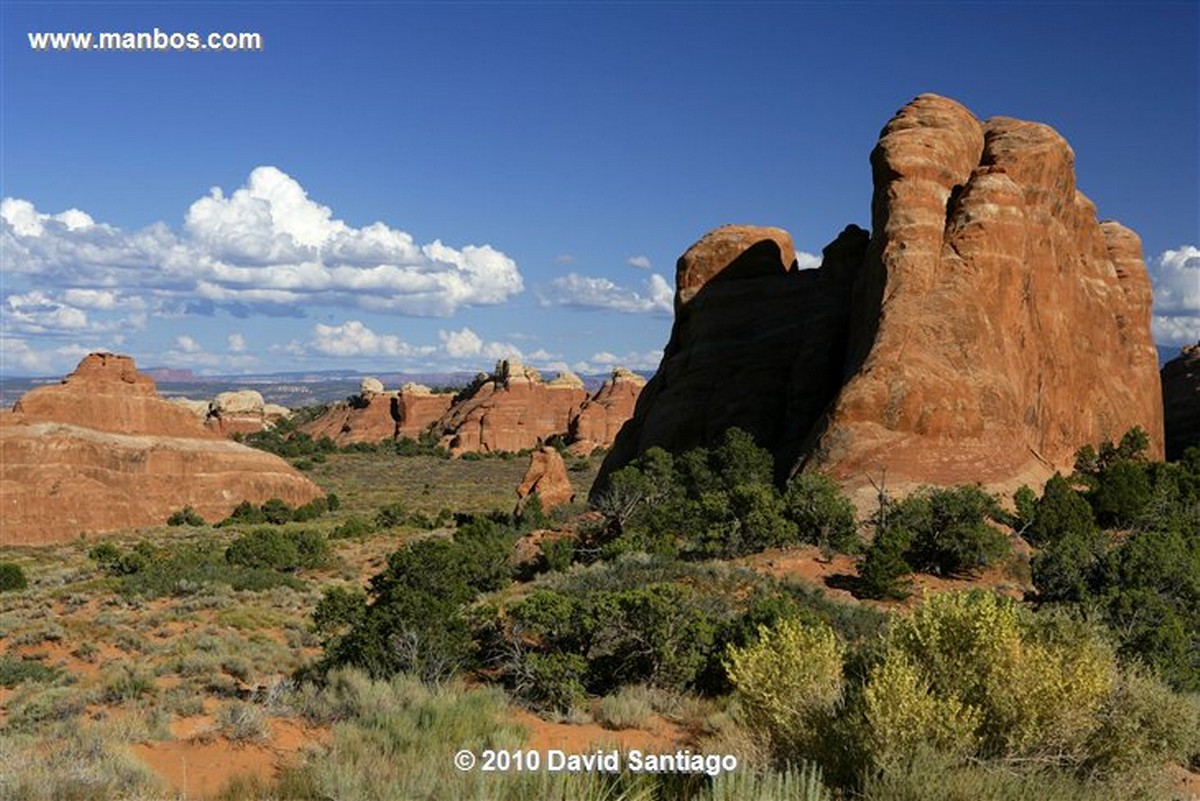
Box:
left=726, top=619, right=844, bottom=760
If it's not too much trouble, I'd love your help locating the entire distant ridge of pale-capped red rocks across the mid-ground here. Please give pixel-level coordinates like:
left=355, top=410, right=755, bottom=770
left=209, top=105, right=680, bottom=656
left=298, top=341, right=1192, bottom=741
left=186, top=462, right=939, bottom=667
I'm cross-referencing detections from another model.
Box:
left=300, top=359, right=646, bottom=456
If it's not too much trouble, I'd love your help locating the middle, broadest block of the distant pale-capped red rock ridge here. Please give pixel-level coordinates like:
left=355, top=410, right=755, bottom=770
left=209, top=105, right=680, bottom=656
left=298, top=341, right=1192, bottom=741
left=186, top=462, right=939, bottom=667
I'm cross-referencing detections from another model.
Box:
left=433, top=359, right=587, bottom=454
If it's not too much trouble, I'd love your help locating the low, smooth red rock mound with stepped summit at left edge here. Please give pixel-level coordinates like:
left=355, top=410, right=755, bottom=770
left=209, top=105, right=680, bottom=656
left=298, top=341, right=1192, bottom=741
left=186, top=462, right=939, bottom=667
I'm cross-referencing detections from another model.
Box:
left=0, top=354, right=323, bottom=546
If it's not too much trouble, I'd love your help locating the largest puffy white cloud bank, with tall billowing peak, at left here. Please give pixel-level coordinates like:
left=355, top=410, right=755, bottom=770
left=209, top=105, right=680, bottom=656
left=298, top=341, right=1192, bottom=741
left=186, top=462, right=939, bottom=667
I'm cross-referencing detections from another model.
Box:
left=0, top=167, right=524, bottom=326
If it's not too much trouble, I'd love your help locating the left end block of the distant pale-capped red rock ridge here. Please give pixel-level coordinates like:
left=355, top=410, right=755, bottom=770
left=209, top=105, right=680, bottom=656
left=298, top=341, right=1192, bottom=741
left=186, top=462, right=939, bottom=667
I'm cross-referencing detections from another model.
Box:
left=300, top=378, right=454, bottom=446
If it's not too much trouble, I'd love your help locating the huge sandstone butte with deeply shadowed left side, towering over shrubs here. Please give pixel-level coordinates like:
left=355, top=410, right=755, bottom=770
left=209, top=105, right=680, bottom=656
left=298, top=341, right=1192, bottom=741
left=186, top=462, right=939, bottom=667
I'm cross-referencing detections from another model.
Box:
left=593, top=95, right=1163, bottom=495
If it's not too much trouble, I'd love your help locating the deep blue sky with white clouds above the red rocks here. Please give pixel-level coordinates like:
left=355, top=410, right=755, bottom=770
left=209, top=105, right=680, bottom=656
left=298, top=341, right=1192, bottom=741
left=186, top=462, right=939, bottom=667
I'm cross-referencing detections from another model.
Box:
left=0, top=0, right=1200, bottom=375
